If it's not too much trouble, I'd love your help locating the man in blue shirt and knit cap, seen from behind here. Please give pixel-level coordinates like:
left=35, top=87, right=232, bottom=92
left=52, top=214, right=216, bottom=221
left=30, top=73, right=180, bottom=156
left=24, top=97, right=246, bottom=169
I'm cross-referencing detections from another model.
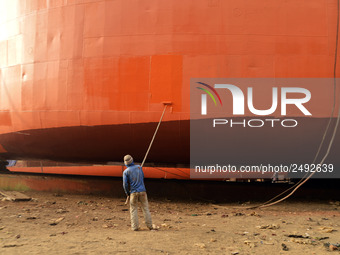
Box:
left=123, top=155, right=152, bottom=231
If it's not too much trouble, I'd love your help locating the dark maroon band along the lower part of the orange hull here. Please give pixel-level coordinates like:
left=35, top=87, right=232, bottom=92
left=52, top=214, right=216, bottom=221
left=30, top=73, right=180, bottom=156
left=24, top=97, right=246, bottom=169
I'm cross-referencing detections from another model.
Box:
left=0, top=117, right=340, bottom=167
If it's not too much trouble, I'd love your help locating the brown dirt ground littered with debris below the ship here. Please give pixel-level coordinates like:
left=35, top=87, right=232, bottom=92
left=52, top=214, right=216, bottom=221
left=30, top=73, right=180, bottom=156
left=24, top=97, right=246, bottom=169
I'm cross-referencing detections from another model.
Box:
left=0, top=191, right=340, bottom=254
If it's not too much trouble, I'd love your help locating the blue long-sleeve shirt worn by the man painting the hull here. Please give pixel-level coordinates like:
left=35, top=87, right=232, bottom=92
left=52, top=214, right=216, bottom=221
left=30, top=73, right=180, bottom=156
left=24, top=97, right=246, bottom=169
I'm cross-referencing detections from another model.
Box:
left=123, top=163, right=146, bottom=196
